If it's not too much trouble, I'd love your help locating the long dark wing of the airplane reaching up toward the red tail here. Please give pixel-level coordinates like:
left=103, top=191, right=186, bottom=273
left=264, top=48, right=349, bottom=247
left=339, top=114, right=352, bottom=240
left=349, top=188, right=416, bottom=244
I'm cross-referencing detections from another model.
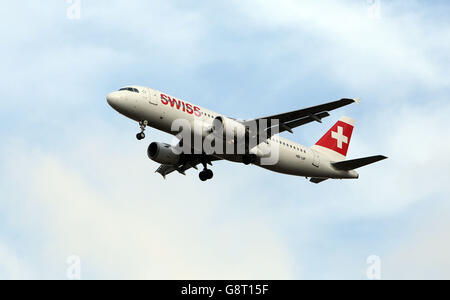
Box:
left=243, top=98, right=359, bottom=142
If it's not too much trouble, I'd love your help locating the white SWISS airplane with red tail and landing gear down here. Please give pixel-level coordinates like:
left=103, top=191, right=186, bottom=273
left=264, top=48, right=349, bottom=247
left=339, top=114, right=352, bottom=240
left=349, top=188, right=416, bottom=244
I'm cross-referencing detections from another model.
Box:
left=106, top=85, right=387, bottom=184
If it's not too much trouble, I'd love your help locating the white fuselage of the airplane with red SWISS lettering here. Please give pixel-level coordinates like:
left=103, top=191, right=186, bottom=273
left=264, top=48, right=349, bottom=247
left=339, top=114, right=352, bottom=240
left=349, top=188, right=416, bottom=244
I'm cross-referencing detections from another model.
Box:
left=107, top=86, right=359, bottom=179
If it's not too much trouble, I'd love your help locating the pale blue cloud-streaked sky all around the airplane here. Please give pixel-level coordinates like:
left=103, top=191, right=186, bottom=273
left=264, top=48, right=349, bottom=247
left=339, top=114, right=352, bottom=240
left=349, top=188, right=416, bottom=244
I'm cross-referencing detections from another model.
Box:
left=0, top=0, right=450, bottom=279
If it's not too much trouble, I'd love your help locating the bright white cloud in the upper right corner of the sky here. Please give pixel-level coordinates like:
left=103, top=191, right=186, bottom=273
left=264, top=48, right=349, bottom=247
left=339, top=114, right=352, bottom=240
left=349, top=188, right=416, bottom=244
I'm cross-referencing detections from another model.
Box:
left=235, top=0, right=450, bottom=95
